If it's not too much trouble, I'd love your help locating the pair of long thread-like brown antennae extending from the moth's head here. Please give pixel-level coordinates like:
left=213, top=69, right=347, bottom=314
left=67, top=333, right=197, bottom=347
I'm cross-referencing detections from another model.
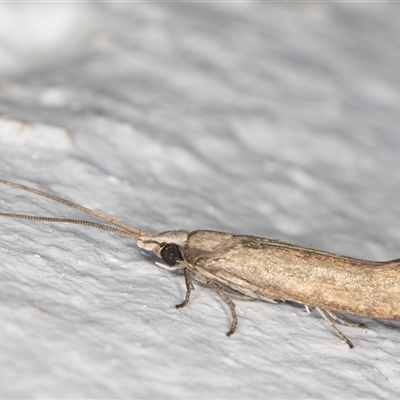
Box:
left=0, top=179, right=144, bottom=240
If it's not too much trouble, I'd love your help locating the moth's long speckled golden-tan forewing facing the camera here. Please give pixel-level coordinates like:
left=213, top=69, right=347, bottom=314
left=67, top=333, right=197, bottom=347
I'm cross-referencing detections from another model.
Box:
left=190, top=235, right=400, bottom=319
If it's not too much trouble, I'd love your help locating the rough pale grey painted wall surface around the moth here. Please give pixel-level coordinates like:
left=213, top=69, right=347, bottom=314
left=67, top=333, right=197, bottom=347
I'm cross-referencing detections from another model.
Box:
left=0, top=2, right=400, bottom=399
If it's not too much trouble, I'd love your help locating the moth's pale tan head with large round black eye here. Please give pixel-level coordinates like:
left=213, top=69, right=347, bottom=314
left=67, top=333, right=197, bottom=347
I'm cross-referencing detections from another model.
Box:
left=137, top=230, right=189, bottom=266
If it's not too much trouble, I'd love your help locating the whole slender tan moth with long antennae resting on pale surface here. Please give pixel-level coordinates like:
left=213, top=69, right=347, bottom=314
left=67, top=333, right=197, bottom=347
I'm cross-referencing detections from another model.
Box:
left=0, top=179, right=400, bottom=348
